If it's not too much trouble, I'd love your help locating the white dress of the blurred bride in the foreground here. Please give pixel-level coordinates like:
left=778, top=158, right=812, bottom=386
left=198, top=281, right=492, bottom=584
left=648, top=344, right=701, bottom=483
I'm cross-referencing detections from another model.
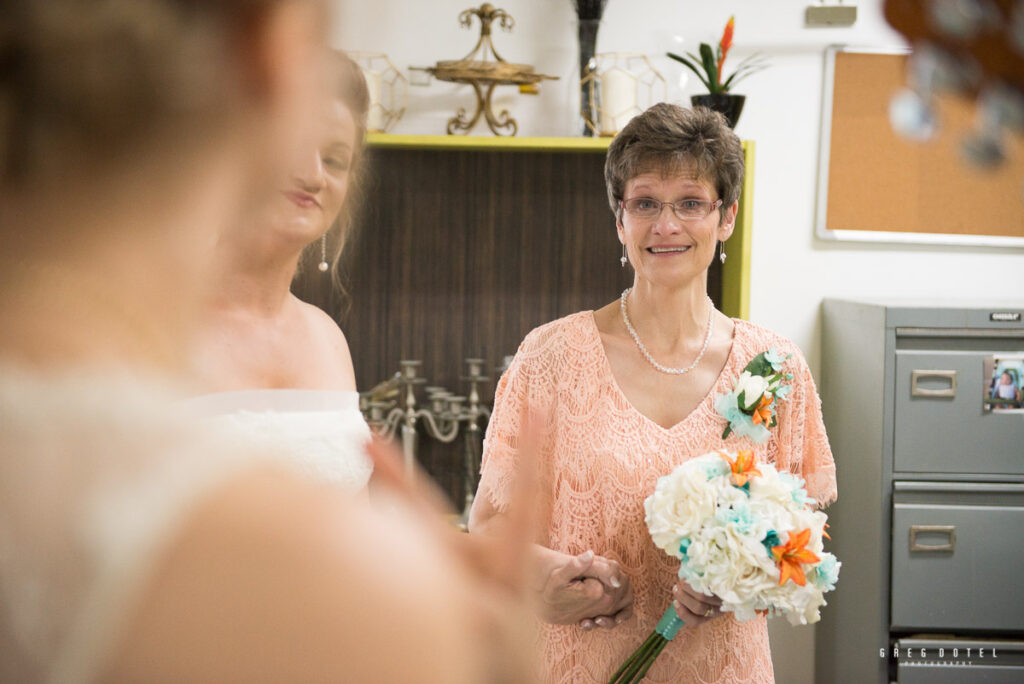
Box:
left=0, top=366, right=278, bottom=684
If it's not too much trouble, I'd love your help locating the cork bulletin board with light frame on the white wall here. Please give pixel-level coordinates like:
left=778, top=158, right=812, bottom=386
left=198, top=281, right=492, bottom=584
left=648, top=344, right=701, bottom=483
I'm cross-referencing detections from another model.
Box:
left=815, top=46, right=1024, bottom=248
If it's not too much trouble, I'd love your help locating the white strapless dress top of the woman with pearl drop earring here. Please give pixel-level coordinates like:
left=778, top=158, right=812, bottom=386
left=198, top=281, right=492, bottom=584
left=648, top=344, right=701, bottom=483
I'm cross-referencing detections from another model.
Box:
left=183, top=389, right=373, bottom=493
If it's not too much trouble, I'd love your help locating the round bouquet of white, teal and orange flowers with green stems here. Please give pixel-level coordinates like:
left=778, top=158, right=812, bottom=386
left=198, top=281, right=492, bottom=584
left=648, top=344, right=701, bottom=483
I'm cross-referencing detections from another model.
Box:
left=610, top=451, right=841, bottom=684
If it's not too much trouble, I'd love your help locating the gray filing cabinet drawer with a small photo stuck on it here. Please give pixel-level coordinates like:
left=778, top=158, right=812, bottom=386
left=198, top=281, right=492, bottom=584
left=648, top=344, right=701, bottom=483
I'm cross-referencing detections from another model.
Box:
left=893, top=350, right=1024, bottom=475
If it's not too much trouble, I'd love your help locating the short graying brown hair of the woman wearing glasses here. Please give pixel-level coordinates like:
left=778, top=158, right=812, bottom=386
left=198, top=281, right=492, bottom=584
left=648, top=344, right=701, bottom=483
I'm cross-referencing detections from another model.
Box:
left=604, top=102, right=743, bottom=223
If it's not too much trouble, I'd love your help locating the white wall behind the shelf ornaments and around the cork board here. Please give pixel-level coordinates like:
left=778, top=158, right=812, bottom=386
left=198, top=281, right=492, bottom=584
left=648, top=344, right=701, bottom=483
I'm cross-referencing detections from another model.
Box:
left=334, top=0, right=1024, bottom=684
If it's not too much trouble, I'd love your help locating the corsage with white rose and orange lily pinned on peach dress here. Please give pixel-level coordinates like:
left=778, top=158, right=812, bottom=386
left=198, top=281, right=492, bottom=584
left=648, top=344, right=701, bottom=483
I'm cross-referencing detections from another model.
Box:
left=715, top=349, right=793, bottom=442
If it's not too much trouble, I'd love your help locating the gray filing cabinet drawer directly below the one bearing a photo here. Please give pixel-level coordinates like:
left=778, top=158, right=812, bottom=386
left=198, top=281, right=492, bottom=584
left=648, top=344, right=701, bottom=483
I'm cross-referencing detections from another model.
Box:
left=891, top=482, right=1024, bottom=631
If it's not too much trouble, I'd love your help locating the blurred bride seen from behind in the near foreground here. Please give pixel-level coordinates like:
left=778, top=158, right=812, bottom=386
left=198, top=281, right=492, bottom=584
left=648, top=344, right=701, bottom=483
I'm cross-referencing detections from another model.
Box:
left=0, top=0, right=525, bottom=684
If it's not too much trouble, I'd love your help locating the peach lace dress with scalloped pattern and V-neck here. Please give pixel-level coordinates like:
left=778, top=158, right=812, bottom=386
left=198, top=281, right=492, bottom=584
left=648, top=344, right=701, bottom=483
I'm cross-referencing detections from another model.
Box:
left=478, top=311, right=837, bottom=684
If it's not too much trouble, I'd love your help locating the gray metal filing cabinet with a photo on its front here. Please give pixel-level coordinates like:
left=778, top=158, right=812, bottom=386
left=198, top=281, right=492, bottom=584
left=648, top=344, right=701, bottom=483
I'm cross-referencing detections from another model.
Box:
left=815, top=299, right=1024, bottom=684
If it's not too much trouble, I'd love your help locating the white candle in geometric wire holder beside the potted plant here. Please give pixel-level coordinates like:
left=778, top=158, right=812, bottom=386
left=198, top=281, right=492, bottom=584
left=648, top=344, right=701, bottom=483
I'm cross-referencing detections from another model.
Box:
left=580, top=52, right=668, bottom=136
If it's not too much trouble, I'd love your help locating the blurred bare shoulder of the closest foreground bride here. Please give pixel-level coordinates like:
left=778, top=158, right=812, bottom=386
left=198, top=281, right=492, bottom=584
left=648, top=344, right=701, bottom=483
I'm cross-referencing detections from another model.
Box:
left=106, top=468, right=489, bottom=682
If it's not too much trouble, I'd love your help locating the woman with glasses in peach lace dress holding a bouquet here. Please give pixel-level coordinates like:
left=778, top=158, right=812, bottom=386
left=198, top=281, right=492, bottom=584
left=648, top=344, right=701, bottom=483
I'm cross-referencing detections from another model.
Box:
left=471, top=104, right=837, bottom=683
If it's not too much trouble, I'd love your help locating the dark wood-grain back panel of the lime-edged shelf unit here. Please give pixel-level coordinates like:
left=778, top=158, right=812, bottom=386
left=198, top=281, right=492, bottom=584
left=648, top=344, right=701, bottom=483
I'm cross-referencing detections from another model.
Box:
left=296, top=148, right=721, bottom=501
